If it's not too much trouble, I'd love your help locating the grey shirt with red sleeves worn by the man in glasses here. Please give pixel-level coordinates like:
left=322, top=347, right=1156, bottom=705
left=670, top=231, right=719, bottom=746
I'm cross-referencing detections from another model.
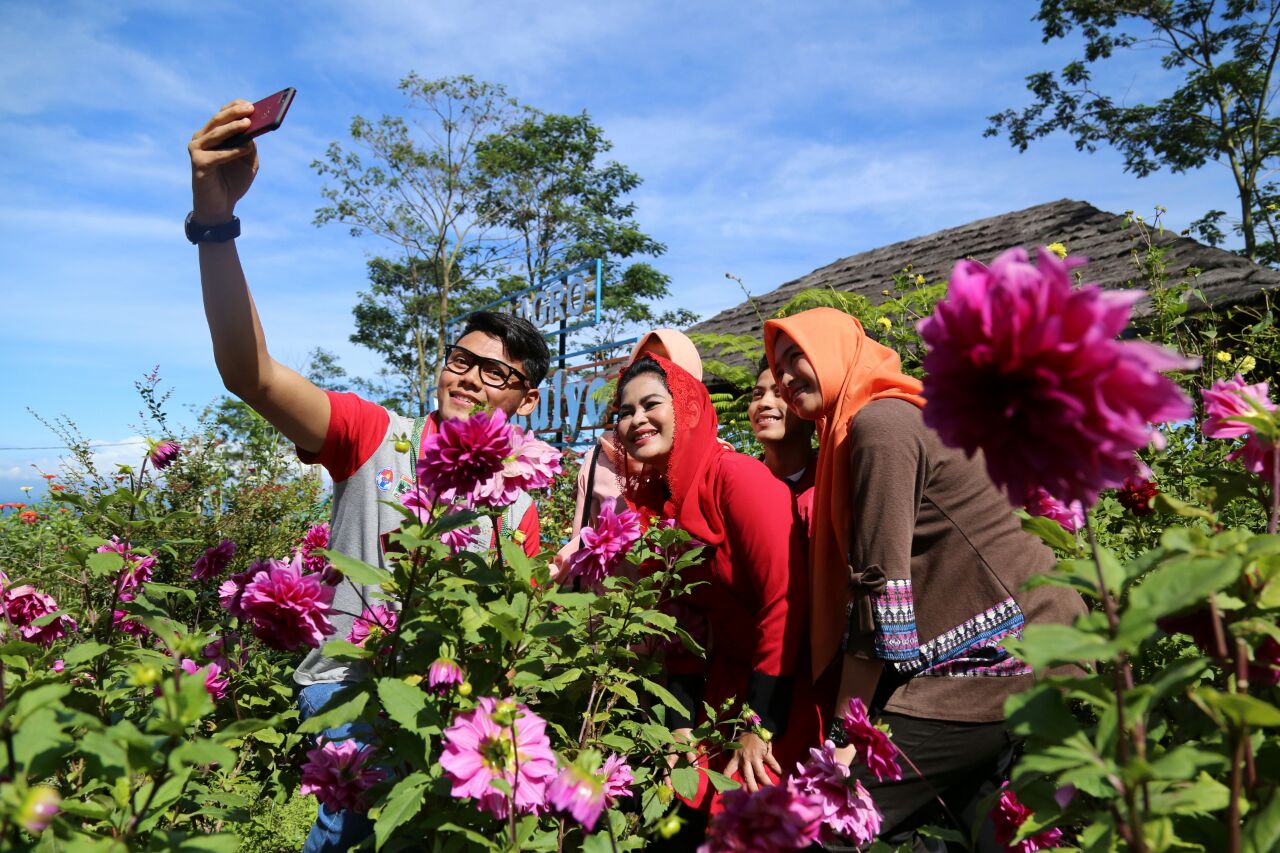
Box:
left=293, top=391, right=541, bottom=686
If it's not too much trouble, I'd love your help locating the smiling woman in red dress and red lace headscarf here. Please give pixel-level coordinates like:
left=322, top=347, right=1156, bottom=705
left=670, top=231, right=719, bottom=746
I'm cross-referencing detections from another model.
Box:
left=614, top=355, right=822, bottom=808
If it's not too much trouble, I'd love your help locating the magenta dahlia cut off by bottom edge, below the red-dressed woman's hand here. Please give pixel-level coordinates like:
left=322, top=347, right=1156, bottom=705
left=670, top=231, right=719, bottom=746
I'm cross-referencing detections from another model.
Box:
left=698, top=783, right=822, bottom=853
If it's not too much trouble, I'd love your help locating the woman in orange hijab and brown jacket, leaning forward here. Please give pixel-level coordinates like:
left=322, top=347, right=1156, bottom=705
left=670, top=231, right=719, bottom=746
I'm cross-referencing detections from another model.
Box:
left=764, top=309, right=1084, bottom=844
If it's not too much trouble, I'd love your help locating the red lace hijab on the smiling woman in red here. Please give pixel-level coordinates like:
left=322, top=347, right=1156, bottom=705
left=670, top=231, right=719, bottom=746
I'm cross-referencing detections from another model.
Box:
left=611, top=353, right=727, bottom=546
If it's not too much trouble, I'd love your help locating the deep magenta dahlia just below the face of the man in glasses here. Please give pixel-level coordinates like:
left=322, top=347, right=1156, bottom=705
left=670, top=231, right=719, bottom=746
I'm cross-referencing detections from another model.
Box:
left=417, top=410, right=515, bottom=506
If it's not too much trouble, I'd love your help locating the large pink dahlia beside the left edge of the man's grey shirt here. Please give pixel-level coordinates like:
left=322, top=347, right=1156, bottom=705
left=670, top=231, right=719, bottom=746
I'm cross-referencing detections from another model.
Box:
left=239, top=560, right=334, bottom=652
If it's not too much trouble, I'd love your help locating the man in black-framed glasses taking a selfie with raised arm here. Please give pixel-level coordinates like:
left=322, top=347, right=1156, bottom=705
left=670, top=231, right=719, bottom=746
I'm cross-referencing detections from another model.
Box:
left=187, top=101, right=550, bottom=852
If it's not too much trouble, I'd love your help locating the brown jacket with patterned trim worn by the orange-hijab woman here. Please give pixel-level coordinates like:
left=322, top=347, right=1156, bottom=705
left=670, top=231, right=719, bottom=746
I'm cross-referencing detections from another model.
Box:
left=846, top=400, right=1084, bottom=722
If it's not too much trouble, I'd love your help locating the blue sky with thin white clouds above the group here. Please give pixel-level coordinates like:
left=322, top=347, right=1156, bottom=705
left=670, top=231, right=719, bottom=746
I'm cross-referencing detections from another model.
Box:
left=0, top=0, right=1233, bottom=501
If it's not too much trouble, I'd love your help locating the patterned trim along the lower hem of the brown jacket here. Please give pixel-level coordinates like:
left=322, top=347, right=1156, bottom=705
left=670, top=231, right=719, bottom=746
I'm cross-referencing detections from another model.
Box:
left=920, top=598, right=1032, bottom=678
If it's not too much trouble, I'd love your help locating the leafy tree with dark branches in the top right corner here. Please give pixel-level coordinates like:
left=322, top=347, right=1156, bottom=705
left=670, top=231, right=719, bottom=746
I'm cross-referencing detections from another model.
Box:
left=986, top=0, right=1280, bottom=264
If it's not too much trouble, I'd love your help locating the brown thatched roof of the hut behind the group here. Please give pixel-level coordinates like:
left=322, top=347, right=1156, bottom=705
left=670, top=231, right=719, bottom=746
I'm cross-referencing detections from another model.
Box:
left=690, top=199, right=1280, bottom=343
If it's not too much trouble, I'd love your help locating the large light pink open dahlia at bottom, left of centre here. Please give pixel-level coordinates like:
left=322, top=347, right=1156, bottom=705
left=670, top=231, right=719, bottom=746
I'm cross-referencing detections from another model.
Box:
left=440, top=697, right=556, bottom=820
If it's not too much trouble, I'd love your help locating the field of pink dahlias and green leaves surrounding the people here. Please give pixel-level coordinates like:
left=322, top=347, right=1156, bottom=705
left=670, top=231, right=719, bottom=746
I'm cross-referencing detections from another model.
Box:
left=0, top=234, right=1280, bottom=853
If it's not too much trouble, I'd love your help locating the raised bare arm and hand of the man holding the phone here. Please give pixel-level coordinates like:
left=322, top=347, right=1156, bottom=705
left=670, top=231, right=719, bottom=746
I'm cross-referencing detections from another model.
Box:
left=187, top=100, right=329, bottom=453
